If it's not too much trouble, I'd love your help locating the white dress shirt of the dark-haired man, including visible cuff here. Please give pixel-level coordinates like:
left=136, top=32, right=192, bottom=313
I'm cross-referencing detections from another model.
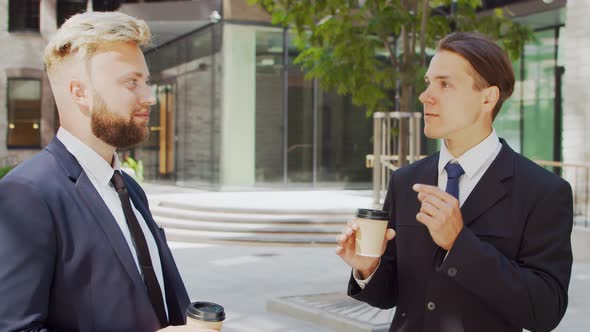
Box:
left=353, top=129, right=502, bottom=289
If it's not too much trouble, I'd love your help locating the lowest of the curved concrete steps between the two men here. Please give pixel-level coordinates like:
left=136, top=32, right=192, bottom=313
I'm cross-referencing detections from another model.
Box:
left=165, top=228, right=336, bottom=245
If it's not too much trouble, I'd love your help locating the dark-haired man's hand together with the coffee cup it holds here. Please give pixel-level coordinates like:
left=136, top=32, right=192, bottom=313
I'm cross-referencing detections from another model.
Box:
left=336, top=209, right=395, bottom=279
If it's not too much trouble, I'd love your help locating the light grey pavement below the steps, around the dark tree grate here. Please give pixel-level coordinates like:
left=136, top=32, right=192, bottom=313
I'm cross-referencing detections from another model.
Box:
left=172, top=243, right=590, bottom=332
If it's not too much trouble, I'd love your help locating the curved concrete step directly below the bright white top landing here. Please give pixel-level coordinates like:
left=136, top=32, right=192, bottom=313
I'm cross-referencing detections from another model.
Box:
left=151, top=205, right=353, bottom=225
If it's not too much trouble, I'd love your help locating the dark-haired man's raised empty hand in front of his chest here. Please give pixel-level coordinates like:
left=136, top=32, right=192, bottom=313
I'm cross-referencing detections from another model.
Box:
left=412, top=184, right=463, bottom=251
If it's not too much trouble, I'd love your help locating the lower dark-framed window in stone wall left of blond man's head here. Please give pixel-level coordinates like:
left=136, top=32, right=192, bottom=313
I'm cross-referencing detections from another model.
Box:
left=6, top=79, right=41, bottom=147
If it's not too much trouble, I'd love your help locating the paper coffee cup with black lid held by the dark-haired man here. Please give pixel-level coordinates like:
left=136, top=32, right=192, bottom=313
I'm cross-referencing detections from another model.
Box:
left=355, top=209, right=389, bottom=257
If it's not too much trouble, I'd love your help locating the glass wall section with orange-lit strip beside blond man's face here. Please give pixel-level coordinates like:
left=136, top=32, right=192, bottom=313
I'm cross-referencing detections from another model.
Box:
left=140, top=26, right=221, bottom=187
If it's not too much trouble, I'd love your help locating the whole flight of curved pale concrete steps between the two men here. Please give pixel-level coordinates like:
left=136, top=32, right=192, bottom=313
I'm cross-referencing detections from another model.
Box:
left=150, top=192, right=363, bottom=244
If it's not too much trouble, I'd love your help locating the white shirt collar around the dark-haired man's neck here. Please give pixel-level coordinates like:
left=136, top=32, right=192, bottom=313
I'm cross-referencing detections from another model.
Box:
left=438, top=128, right=500, bottom=178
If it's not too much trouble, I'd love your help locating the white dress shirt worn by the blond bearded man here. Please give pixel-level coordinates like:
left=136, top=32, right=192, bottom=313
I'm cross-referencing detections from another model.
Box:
left=57, top=127, right=168, bottom=314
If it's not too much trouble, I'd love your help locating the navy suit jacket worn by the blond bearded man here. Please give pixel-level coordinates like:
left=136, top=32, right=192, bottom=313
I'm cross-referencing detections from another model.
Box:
left=0, top=138, right=189, bottom=332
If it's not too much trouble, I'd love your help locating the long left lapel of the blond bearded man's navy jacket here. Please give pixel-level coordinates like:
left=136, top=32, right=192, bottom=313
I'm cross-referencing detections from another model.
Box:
left=46, top=138, right=145, bottom=287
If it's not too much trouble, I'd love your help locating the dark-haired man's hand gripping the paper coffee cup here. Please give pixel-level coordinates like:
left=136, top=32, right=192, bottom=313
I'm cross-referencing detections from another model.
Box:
left=336, top=221, right=395, bottom=279
